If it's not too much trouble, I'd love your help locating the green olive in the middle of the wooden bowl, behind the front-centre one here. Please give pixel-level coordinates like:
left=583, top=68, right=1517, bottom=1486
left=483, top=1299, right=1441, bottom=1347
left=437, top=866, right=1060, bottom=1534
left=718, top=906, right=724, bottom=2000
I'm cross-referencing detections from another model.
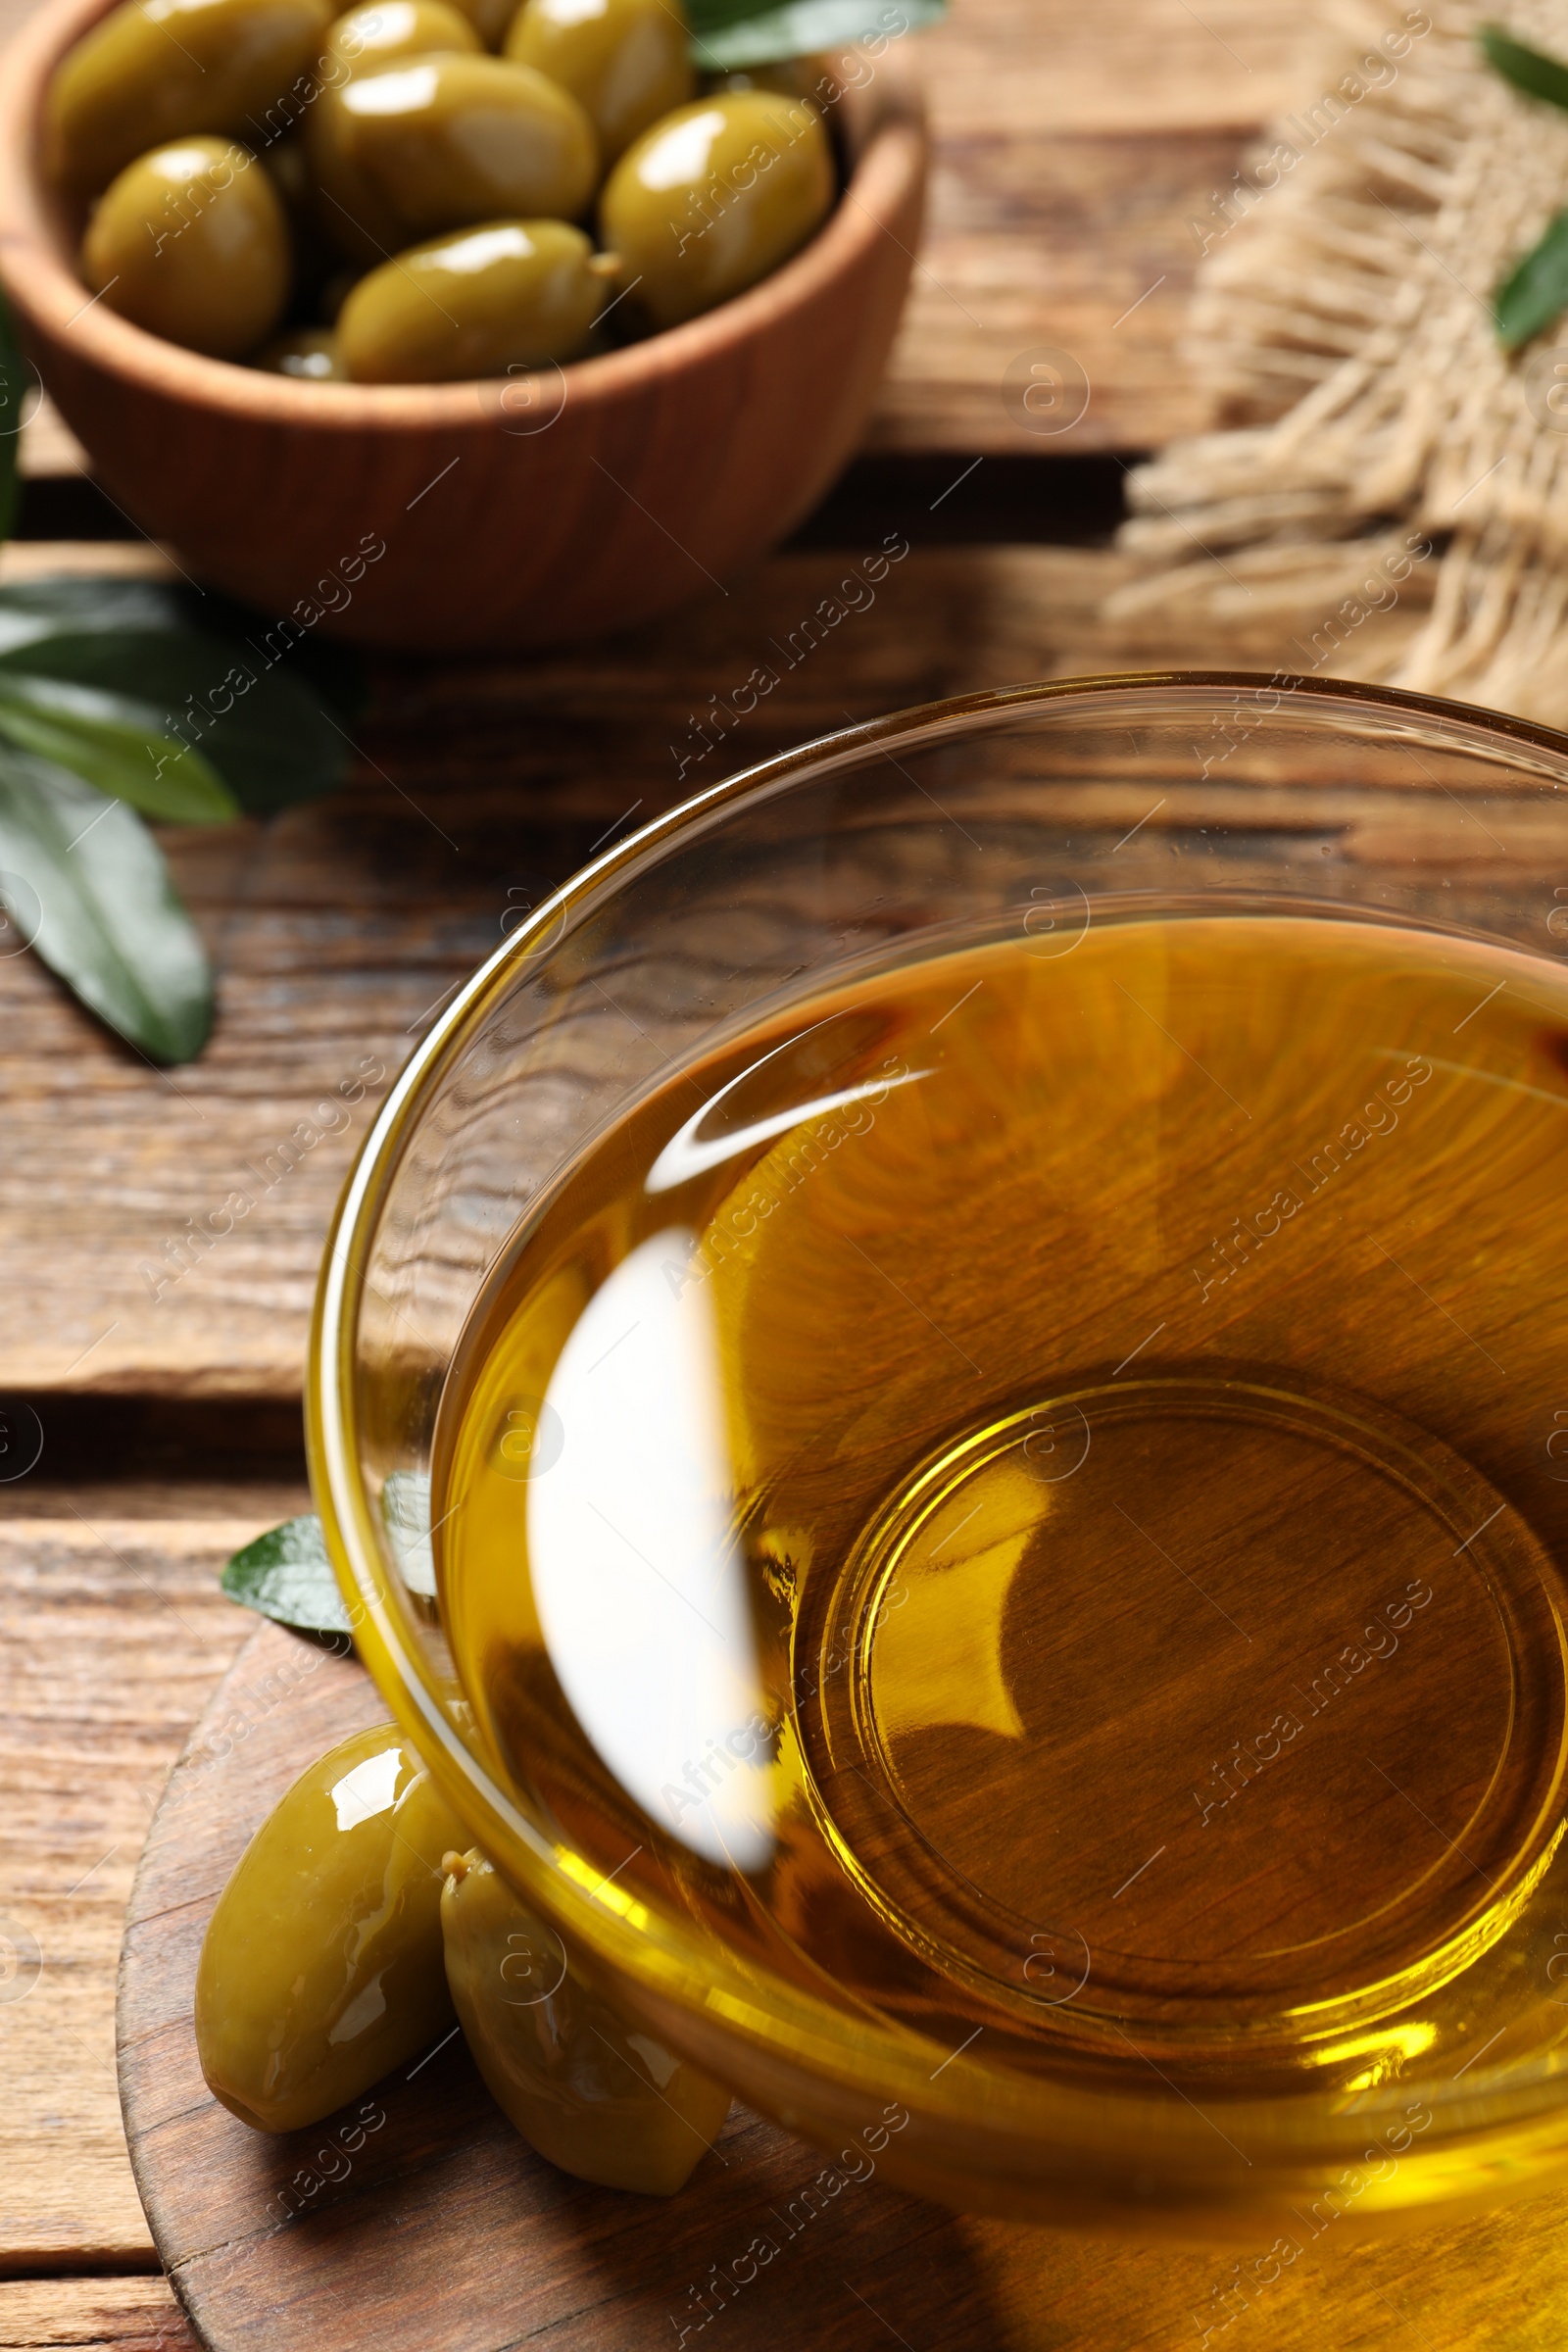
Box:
left=331, top=57, right=600, bottom=245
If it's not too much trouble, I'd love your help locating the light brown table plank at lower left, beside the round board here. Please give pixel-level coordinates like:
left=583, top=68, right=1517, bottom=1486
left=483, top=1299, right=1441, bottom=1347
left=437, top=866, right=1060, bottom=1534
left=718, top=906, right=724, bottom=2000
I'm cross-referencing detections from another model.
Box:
left=0, top=1482, right=308, bottom=2267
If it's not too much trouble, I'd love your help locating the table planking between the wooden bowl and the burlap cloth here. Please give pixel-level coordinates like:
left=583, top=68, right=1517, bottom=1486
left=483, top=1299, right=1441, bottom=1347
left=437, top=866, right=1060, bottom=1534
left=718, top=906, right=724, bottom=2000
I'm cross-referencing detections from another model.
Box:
left=0, top=0, right=1326, bottom=472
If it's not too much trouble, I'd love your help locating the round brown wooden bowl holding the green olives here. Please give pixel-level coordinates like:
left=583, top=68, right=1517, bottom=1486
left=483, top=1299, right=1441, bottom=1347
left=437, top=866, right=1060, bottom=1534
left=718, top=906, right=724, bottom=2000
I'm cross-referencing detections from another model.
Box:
left=0, top=0, right=926, bottom=649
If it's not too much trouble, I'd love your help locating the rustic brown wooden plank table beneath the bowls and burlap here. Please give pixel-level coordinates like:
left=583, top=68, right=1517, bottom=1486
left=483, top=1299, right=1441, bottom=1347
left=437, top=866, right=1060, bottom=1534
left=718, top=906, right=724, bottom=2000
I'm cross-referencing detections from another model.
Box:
left=0, top=0, right=1568, bottom=2352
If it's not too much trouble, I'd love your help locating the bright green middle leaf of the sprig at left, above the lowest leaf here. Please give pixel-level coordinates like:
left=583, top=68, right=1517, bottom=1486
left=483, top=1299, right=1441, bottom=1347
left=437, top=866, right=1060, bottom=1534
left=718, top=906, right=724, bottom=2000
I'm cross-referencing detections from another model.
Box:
left=0, top=668, right=240, bottom=825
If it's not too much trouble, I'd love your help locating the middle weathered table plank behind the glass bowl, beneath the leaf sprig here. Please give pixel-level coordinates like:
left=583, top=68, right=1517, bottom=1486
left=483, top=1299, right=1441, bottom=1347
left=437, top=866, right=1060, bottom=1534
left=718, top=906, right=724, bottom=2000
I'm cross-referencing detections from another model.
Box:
left=0, top=536, right=1439, bottom=1418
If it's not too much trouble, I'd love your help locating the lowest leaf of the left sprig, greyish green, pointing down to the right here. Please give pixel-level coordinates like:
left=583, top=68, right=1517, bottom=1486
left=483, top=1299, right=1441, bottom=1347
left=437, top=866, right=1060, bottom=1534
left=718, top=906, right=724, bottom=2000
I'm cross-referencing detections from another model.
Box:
left=0, top=746, right=212, bottom=1060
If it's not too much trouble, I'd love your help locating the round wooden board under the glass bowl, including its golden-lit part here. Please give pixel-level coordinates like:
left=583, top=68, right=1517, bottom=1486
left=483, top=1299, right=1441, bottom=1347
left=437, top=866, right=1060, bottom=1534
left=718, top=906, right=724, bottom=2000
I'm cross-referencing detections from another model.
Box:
left=120, top=1628, right=1568, bottom=2352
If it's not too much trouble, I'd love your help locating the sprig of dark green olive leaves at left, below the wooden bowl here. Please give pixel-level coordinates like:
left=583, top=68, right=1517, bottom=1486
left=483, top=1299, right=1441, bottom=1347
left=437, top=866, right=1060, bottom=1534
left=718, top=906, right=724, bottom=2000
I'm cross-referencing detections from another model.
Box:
left=0, top=299, right=362, bottom=1060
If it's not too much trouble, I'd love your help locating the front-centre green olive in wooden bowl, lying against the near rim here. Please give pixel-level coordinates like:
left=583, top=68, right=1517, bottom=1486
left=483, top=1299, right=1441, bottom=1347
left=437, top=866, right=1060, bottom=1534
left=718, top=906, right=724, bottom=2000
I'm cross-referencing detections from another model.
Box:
left=338, top=221, right=615, bottom=383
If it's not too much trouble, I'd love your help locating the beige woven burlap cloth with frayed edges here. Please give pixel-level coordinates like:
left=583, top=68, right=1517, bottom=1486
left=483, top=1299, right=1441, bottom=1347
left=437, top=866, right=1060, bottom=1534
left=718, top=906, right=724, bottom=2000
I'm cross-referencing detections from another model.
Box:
left=1104, top=0, right=1568, bottom=727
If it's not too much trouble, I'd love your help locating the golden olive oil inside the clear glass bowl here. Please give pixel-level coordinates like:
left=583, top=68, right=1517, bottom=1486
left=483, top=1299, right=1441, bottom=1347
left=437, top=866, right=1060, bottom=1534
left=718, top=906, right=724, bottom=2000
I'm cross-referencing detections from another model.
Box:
left=435, top=910, right=1568, bottom=2095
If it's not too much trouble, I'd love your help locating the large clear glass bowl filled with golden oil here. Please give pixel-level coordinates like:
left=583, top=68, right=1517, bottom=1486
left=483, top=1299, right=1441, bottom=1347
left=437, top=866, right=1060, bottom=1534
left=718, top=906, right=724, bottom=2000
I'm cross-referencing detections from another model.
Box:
left=308, top=675, right=1568, bottom=2241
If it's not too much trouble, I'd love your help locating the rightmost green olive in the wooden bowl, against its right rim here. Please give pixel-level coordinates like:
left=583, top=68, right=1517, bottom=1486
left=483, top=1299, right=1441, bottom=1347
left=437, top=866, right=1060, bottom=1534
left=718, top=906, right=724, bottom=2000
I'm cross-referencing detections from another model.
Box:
left=600, top=89, right=832, bottom=327
